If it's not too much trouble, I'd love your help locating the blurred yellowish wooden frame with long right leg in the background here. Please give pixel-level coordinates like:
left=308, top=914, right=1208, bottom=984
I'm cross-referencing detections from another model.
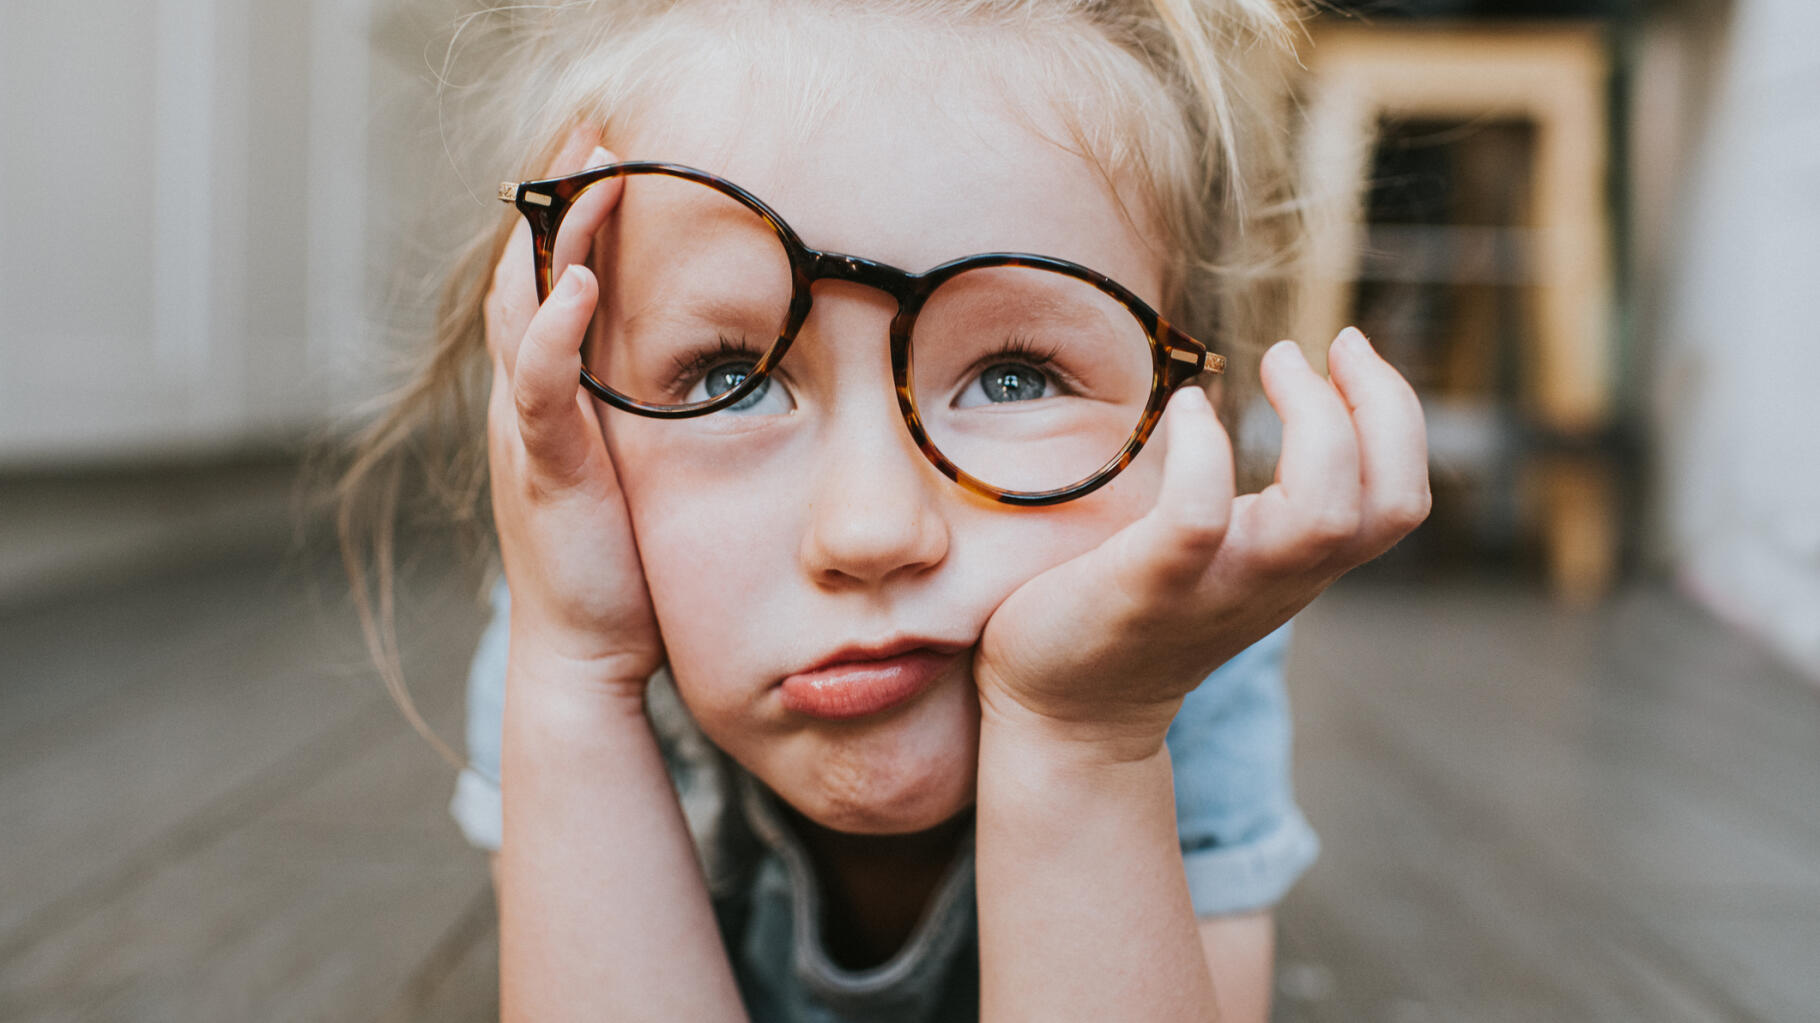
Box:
left=1296, top=24, right=1618, bottom=599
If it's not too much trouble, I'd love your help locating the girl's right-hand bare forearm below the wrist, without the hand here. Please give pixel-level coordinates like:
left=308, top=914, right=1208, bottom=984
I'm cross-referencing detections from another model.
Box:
left=976, top=714, right=1216, bottom=1023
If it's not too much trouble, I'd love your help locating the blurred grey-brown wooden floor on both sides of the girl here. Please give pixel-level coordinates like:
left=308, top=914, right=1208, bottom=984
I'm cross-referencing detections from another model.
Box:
left=0, top=546, right=1820, bottom=1023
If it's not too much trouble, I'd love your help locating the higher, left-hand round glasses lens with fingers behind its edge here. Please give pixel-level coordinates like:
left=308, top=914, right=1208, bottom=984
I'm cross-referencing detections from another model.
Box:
left=551, top=173, right=792, bottom=411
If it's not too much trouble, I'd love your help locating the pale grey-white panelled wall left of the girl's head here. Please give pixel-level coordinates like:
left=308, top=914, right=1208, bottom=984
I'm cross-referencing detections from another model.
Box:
left=0, top=0, right=373, bottom=468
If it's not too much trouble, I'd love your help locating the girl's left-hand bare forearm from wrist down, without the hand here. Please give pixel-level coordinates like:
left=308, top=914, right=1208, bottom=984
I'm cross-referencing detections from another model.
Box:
left=499, top=655, right=744, bottom=1023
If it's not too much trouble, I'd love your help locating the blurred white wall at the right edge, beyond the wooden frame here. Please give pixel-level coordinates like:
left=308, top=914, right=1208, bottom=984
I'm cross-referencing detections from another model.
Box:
left=1645, top=0, right=1820, bottom=677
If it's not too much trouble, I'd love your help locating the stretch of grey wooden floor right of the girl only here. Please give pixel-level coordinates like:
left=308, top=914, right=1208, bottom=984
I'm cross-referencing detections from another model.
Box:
left=1278, top=584, right=1820, bottom=1023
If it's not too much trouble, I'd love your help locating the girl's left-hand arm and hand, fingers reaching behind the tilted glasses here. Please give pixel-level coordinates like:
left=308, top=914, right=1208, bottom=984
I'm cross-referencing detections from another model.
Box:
left=484, top=131, right=744, bottom=1023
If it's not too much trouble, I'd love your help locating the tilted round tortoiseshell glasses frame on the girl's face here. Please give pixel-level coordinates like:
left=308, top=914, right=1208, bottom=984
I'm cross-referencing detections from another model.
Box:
left=499, top=160, right=1227, bottom=506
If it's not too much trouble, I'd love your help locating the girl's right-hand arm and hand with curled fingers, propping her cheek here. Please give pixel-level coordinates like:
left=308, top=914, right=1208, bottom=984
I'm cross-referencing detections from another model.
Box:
left=974, top=331, right=1429, bottom=1023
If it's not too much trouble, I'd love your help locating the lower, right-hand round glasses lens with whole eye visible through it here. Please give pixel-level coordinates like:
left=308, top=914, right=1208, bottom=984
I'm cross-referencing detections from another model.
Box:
left=910, top=266, right=1154, bottom=493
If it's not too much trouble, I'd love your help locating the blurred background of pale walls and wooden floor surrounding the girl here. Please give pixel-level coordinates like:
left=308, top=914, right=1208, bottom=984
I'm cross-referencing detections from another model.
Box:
left=0, top=0, right=1820, bottom=1023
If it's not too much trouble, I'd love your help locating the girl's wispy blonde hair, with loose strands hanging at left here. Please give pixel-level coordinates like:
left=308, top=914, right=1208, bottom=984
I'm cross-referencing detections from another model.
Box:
left=335, top=0, right=1301, bottom=763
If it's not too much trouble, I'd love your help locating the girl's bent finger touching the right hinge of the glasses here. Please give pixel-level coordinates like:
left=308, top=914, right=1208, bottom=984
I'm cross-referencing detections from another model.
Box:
left=1127, top=388, right=1236, bottom=588
